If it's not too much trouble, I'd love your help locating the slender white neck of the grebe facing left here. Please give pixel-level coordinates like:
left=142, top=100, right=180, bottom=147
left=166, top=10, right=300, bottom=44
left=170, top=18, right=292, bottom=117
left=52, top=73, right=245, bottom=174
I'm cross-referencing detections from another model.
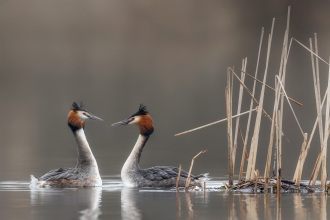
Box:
left=121, top=134, right=149, bottom=185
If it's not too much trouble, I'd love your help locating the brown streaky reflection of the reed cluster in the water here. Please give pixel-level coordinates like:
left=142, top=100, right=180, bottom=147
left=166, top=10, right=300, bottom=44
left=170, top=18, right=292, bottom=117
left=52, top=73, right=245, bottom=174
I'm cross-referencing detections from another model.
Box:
left=223, top=192, right=327, bottom=220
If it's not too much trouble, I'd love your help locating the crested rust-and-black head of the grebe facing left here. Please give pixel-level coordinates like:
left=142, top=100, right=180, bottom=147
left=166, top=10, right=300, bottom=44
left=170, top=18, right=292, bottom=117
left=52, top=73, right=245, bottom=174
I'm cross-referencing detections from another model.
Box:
left=111, top=104, right=154, bottom=136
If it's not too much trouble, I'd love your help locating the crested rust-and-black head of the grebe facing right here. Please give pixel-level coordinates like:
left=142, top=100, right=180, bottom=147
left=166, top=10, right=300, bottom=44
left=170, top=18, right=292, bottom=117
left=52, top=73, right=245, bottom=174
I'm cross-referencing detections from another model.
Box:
left=68, top=102, right=103, bottom=131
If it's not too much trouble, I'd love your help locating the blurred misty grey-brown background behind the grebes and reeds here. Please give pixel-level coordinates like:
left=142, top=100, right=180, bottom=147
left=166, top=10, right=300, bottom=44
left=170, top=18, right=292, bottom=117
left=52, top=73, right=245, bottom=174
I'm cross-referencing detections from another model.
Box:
left=0, top=0, right=330, bottom=181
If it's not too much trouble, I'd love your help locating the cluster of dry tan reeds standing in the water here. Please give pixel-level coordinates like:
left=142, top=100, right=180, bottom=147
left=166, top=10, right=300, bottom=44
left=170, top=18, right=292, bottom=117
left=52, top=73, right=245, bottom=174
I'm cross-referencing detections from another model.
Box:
left=176, top=6, right=330, bottom=192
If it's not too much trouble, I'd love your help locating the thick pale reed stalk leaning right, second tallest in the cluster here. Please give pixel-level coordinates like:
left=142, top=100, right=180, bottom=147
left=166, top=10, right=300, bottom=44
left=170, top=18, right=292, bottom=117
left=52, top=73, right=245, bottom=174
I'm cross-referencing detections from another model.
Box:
left=246, top=18, right=275, bottom=180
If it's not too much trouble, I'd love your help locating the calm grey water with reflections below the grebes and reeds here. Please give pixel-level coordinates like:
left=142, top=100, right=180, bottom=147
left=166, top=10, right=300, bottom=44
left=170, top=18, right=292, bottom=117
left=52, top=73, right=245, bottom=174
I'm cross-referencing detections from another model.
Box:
left=0, top=176, right=330, bottom=220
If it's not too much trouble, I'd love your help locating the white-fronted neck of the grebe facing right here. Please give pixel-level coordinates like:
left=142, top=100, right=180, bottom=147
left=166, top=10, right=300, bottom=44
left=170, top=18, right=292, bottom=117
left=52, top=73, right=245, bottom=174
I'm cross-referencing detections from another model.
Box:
left=73, top=128, right=99, bottom=175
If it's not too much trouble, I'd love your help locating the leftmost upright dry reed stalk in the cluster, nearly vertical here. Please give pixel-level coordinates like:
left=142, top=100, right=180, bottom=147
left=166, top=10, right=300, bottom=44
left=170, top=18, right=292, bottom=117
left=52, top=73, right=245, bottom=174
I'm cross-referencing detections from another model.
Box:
left=226, top=68, right=234, bottom=186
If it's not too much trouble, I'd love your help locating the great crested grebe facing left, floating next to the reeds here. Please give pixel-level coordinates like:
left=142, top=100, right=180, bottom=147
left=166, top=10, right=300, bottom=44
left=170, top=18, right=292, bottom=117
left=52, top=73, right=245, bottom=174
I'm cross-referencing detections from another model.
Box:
left=112, top=104, right=206, bottom=187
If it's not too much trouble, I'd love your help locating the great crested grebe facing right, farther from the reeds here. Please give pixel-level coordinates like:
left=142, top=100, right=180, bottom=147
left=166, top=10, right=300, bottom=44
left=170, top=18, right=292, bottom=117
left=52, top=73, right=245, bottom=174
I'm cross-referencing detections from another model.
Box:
left=30, top=102, right=102, bottom=188
